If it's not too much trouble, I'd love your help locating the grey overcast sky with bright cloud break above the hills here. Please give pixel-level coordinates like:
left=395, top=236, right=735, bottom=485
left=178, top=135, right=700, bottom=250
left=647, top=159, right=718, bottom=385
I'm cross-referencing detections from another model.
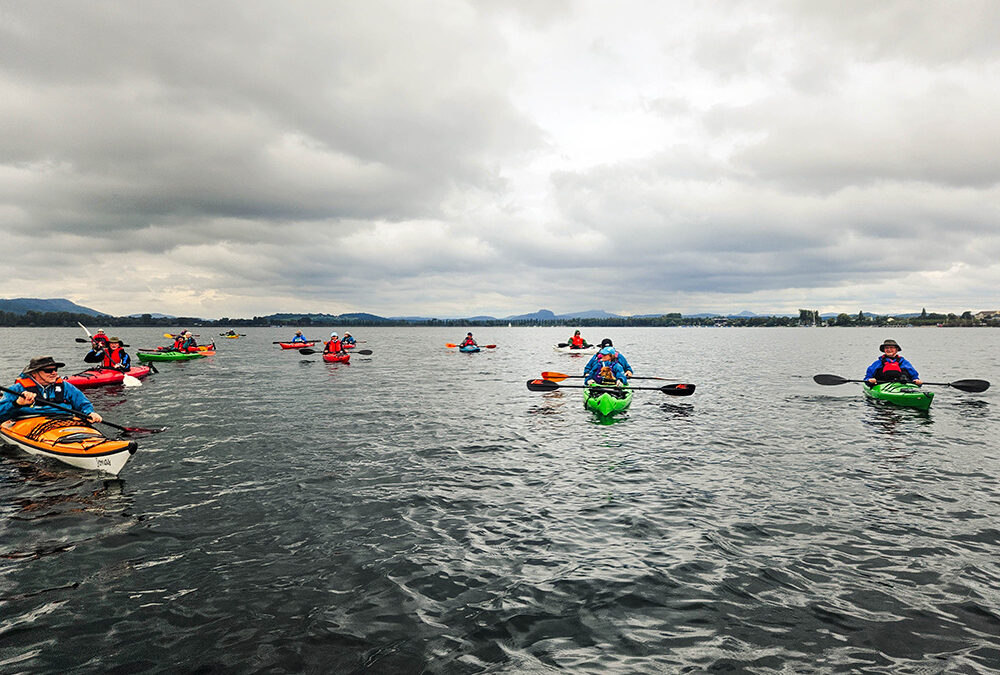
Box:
left=0, top=0, right=1000, bottom=317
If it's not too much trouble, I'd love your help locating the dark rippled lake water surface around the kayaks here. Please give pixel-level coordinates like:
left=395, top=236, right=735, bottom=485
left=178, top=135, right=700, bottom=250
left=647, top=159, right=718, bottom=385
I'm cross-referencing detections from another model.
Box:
left=0, top=328, right=1000, bottom=673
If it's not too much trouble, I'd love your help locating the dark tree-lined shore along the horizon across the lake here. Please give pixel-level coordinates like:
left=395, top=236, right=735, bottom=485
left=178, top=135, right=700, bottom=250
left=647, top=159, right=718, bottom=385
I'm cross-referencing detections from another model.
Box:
left=0, top=309, right=1000, bottom=328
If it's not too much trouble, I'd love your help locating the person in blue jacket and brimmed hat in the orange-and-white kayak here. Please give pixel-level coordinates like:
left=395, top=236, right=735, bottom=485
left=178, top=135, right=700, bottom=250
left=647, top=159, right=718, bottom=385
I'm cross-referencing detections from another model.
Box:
left=0, top=356, right=102, bottom=424
